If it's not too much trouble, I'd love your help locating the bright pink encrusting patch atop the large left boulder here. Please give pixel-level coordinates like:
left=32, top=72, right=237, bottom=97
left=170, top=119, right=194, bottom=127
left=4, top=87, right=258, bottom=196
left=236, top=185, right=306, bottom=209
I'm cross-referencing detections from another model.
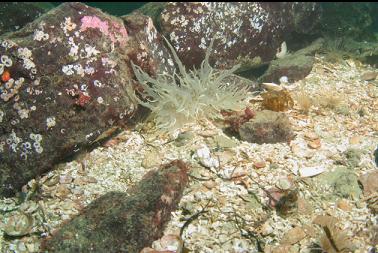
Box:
left=80, top=16, right=128, bottom=46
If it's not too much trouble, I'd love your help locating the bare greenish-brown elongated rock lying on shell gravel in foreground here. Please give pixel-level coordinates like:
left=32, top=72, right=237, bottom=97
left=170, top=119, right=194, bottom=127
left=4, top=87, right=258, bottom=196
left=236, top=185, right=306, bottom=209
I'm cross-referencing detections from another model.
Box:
left=44, top=160, right=188, bottom=253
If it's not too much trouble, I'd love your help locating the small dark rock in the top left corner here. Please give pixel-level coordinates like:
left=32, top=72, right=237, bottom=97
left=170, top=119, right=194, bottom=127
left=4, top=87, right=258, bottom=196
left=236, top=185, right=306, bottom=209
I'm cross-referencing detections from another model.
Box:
left=0, top=2, right=54, bottom=35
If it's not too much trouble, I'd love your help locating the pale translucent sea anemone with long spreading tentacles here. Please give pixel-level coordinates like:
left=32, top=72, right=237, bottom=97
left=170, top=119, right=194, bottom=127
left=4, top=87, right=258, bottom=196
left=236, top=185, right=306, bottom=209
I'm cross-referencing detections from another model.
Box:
left=132, top=37, right=247, bottom=132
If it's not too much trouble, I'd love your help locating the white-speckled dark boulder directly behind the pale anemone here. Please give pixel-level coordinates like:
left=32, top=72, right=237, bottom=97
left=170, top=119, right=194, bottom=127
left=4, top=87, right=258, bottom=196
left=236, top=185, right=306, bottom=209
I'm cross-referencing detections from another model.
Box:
left=161, top=2, right=320, bottom=70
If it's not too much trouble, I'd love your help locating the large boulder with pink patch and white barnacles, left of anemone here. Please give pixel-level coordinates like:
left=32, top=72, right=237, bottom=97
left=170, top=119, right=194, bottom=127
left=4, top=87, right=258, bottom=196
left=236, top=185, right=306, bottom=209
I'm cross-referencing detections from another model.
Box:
left=0, top=3, right=174, bottom=196
